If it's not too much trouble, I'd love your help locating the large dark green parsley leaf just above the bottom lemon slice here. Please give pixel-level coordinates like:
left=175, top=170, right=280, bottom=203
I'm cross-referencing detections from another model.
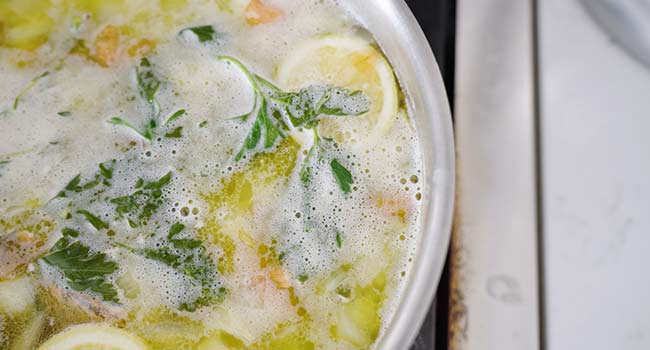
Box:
left=42, top=237, right=118, bottom=302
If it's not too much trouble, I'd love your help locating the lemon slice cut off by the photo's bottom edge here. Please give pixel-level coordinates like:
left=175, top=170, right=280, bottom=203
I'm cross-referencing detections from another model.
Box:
left=38, top=323, right=148, bottom=350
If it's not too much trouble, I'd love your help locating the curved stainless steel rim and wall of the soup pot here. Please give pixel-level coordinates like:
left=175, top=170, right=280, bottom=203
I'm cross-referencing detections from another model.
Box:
left=343, top=0, right=455, bottom=350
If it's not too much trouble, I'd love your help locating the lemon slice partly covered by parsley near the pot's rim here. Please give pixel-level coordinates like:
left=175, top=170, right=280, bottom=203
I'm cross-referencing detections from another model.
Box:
left=276, top=35, right=398, bottom=146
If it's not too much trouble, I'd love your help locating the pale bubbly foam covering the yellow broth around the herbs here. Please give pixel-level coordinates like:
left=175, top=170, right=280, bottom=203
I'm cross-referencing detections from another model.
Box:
left=0, top=0, right=423, bottom=349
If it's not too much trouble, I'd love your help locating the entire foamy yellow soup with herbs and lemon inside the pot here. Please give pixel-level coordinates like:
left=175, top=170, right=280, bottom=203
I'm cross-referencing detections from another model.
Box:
left=0, top=0, right=424, bottom=350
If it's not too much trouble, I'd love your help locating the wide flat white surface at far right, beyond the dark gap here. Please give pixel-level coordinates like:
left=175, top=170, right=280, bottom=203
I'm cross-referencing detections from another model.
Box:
left=539, top=0, right=650, bottom=350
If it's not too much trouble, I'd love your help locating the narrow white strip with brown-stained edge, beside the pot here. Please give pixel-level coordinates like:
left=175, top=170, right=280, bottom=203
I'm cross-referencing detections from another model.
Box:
left=450, top=0, right=539, bottom=350
